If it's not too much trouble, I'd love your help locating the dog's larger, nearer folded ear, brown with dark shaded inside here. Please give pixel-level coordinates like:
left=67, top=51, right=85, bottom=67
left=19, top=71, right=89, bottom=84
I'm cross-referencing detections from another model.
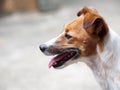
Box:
left=83, top=16, right=108, bottom=39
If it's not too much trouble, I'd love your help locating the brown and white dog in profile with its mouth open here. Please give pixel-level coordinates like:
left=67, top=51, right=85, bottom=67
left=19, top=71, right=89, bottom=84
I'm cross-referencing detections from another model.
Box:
left=39, top=7, right=120, bottom=90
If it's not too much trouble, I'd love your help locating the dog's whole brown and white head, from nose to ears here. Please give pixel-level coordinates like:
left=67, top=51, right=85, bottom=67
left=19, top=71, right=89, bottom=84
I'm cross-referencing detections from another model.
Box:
left=40, top=7, right=108, bottom=68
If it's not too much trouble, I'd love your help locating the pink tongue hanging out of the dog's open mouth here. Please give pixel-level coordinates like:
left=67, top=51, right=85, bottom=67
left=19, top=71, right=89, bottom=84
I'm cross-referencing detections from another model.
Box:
left=48, top=53, right=68, bottom=68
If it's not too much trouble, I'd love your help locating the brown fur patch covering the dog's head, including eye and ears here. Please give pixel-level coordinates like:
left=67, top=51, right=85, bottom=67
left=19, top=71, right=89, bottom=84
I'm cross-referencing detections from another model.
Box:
left=56, top=7, right=108, bottom=57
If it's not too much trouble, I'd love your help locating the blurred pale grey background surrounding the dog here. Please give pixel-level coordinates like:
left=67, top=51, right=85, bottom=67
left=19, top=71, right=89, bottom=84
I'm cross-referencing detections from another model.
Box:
left=0, top=0, right=120, bottom=90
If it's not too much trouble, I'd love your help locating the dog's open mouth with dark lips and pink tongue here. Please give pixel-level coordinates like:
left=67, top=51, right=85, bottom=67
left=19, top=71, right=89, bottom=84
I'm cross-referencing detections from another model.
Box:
left=48, top=48, right=80, bottom=68
